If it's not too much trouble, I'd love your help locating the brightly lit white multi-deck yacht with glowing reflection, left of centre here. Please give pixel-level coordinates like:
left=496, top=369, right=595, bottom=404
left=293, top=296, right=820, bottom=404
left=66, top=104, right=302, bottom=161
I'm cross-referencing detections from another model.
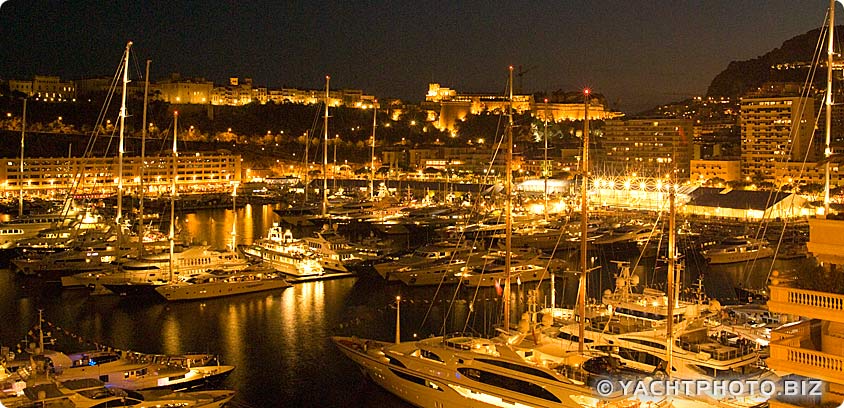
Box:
left=238, top=224, right=325, bottom=278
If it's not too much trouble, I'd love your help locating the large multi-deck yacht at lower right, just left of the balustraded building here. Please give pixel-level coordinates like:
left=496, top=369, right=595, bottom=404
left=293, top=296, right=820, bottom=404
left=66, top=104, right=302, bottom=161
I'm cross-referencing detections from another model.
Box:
left=524, top=263, right=775, bottom=406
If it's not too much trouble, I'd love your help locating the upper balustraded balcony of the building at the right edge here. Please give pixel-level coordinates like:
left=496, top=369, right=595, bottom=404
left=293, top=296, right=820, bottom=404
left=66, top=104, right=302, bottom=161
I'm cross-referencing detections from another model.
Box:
left=768, top=285, right=844, bottom=323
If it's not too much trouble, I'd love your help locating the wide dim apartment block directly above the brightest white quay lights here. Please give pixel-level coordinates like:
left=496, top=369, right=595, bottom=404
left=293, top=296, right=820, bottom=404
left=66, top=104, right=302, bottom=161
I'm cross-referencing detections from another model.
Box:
left=595, top=118, right=694, bottom=180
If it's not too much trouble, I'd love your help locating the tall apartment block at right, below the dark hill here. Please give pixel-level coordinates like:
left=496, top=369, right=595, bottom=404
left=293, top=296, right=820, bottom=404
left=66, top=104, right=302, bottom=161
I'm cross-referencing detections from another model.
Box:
left=740, top=96, right=817, bottom=185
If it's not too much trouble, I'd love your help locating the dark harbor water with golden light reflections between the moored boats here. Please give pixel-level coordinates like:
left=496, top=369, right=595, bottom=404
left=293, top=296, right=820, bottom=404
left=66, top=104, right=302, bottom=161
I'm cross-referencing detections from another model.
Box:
left=0, top=206, right=810, bottom=407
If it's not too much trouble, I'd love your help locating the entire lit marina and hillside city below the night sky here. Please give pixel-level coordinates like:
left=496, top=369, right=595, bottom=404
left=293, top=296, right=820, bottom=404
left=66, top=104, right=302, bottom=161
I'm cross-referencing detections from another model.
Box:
left=0, top=0, right=844, bottom=408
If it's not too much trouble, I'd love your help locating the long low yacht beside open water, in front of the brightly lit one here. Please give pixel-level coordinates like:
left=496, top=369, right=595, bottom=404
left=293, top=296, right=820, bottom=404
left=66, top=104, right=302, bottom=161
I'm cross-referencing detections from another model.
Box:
left=155, top=267, right=292, bottom=301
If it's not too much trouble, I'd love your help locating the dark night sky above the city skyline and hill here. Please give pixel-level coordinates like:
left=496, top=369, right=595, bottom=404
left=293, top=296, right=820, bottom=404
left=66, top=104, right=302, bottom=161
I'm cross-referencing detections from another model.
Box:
left=0, top=0, right=832, bottom=113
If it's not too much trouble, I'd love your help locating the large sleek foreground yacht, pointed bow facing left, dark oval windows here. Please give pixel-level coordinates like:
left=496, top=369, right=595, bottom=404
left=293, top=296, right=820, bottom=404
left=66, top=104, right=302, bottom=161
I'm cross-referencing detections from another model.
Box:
left=333, top=336, right=659, bottom=408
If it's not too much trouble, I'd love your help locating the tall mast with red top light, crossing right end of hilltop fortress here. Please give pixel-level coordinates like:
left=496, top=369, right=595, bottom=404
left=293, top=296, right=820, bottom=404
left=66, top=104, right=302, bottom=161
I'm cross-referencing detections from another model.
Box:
left=577, top=89, right=589, bottom=353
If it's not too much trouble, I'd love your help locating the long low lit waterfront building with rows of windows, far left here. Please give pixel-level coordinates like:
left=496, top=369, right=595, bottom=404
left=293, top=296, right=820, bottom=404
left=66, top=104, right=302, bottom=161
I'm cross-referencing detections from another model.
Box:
left=0, top=153, right=241, bottom=197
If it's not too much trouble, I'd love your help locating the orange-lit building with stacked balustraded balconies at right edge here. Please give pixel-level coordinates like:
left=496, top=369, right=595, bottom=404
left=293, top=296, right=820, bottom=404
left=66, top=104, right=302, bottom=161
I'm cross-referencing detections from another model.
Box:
left=766, top=218, right=844, bottom=408
